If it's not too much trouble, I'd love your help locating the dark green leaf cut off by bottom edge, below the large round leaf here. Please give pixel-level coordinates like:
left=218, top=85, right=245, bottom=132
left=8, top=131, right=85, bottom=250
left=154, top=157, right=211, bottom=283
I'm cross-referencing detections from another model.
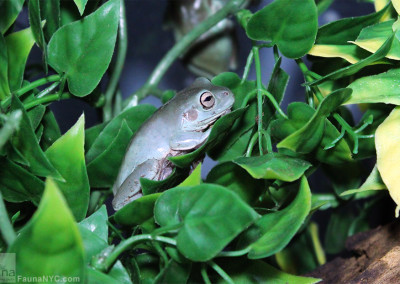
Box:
left=154, top=259, right=192, bottom=284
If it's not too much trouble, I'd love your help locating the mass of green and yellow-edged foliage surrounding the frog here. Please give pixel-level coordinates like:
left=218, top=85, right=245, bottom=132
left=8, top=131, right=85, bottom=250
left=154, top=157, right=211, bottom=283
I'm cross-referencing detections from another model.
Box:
left=0, top=0, right=400, bottom=283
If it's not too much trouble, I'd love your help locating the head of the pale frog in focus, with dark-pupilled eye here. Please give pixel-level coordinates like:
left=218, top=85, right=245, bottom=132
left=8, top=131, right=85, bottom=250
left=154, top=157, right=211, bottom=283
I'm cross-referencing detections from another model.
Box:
left=180, top=77, right=235, bottom=132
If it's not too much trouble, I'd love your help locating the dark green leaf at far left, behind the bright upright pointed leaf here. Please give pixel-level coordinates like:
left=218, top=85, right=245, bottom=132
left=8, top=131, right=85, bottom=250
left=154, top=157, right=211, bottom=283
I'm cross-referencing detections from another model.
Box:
left=11, top=96, right=61, bottom=179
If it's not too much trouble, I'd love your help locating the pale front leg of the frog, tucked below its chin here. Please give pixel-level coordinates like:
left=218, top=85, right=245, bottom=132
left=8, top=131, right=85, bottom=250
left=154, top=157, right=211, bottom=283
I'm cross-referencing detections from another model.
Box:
left=169, top=128, right=211, bottom=151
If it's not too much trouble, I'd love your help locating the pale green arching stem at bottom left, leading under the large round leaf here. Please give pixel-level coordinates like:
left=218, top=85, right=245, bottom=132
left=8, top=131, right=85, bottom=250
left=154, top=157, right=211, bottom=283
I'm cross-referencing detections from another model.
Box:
left=92, top=234, right=176, bottom=271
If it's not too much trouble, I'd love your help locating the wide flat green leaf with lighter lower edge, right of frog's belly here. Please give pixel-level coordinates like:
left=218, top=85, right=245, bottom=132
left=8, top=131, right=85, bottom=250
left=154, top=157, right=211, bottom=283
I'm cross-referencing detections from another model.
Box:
left=233, top=153, right=311, bottom=182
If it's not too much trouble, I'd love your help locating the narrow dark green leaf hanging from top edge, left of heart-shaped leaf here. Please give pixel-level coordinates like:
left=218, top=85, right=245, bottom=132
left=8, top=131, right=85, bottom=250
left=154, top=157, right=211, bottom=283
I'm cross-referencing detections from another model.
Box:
left=28, top=0, right=48, bottom=73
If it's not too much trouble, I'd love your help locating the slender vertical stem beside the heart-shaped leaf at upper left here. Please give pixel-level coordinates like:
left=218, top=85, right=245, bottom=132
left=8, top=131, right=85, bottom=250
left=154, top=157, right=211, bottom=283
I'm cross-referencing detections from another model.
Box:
left=103, top=0, right=128, bottom=121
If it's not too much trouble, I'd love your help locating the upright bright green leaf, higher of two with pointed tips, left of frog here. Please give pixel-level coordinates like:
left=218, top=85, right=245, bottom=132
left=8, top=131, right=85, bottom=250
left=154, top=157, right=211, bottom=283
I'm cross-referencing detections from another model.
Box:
left=46, top=115, right=90, bottom=221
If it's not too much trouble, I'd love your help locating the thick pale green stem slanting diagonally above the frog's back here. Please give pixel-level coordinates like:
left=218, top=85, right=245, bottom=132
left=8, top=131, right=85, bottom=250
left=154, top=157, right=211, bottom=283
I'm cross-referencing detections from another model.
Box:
left=126, top=0, right=245, bottom=105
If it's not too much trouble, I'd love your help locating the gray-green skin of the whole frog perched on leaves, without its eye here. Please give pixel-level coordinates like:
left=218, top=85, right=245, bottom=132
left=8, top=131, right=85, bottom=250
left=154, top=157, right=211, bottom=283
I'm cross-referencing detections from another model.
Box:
left=112, top=78, right=235, bottom=210
